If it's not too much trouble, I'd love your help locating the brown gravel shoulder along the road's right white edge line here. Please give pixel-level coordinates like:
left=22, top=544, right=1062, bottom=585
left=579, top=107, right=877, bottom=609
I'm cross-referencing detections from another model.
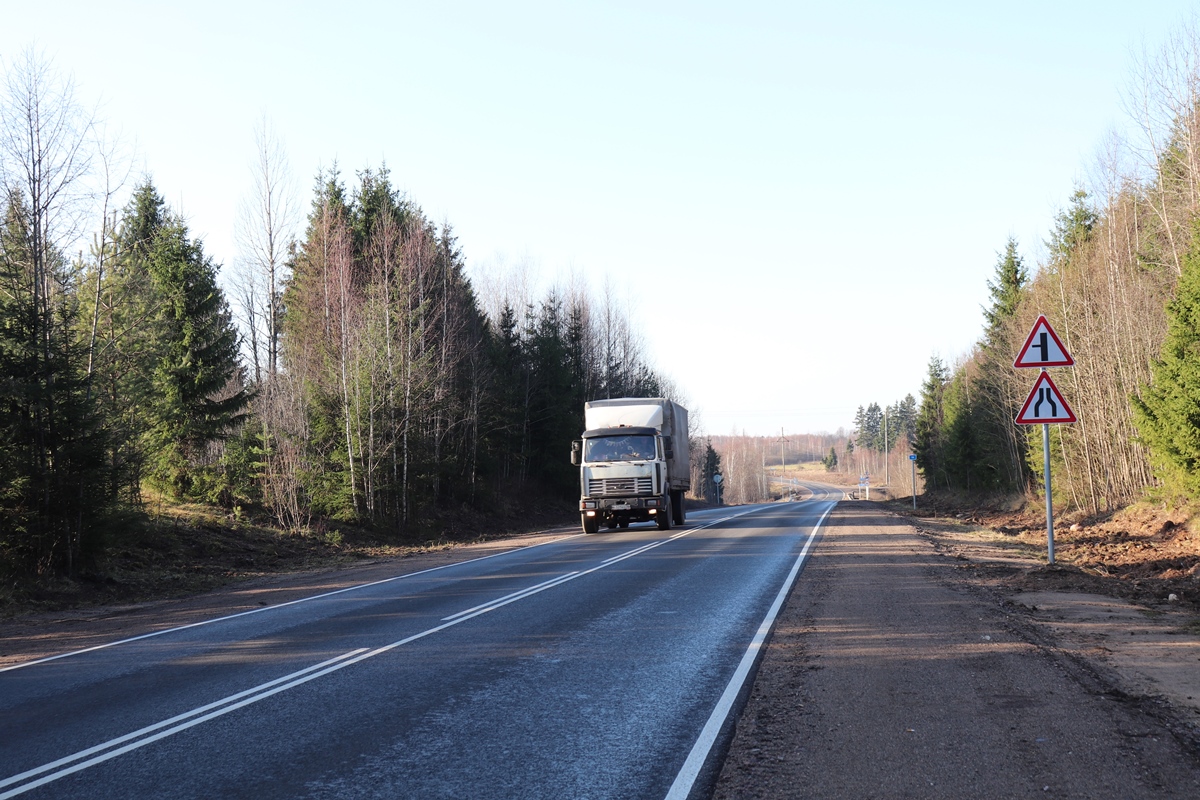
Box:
left=714, top=501, right=1200, bottom=799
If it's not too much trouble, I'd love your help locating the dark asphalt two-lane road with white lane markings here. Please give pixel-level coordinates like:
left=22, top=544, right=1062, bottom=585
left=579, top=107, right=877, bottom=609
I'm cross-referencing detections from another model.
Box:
left=0, top=487, right=841, bottom=800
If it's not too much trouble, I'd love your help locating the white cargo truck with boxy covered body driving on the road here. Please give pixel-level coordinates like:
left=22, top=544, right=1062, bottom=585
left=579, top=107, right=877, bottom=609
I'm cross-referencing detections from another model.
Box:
left=571, top=397, right=691, bottom=534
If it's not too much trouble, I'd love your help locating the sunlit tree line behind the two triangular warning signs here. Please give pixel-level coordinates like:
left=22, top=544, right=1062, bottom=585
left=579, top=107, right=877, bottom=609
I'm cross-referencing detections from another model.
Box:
left=914, top=25, right=1200, bottom=513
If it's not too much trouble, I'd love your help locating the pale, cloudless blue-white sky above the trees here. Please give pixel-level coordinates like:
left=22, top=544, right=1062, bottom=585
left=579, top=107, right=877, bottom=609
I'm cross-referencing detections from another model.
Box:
left=0, top=0, right=1195, bottom=435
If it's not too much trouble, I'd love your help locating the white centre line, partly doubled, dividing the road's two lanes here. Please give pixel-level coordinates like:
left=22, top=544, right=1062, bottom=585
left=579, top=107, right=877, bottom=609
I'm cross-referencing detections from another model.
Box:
left=0, top=506, right=796, bottom=800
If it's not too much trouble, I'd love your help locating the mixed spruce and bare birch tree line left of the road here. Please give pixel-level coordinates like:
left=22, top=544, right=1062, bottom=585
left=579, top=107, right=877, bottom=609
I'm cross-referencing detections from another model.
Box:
left=0, top=53, right=676, bottom=576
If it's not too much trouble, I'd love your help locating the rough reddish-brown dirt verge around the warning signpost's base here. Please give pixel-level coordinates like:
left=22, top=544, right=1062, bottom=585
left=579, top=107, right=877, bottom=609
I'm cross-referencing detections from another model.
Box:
left=893, top=505, right=1200, bottom=734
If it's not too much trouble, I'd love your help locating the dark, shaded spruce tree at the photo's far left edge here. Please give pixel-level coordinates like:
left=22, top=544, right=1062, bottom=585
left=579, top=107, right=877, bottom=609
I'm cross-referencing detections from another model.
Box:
left=0, top=193, right=104, bottom=573
